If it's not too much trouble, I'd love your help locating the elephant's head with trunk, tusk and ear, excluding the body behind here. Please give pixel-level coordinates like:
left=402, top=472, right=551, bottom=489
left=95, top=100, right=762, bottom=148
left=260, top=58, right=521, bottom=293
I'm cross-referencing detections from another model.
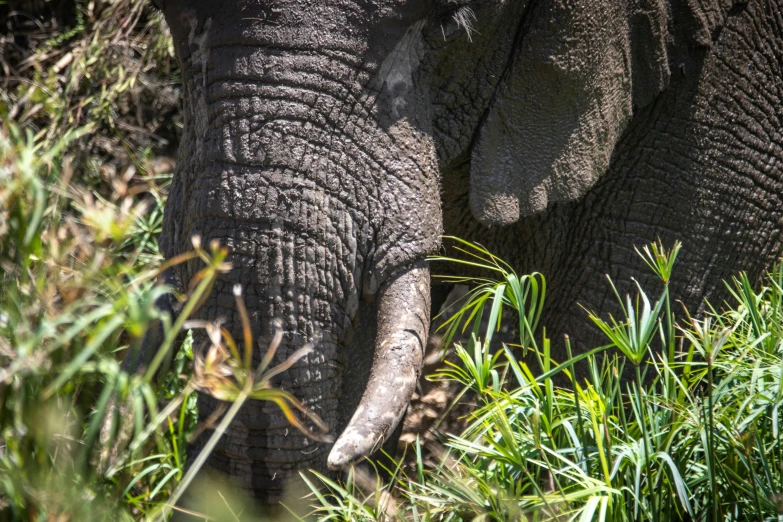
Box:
left=158, top=0, right=736, bottom=498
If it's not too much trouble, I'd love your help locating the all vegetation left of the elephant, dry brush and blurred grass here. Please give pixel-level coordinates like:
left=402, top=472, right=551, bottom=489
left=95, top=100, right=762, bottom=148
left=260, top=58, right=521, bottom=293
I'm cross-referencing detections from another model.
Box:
left=0, top=4, right=324, bottom=520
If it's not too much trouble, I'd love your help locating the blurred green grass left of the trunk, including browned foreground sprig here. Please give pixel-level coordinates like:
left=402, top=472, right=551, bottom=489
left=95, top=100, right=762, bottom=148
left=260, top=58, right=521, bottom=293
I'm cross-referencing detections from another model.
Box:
left=0, top=125, right=326, bottom=520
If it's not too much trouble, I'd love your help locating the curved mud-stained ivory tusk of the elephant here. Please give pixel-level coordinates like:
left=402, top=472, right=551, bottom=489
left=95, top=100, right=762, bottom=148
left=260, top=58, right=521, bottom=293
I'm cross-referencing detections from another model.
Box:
left=327, top=262, right=430, bottom=470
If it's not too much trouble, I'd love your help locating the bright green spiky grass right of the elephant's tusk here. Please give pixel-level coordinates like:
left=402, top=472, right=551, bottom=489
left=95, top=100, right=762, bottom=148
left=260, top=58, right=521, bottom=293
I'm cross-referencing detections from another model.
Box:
left=304, top=242, right=783, bottom=522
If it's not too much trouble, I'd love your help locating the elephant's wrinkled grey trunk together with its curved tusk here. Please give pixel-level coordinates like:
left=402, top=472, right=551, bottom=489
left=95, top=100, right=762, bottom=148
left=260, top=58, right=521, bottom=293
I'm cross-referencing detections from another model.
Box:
left=161, top=2, right=442, bottom=503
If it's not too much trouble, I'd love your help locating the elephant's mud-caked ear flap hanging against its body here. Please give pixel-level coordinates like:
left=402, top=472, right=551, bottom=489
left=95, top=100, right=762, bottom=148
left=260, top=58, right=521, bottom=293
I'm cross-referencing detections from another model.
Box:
left=470, top=0, right=670, bottom=225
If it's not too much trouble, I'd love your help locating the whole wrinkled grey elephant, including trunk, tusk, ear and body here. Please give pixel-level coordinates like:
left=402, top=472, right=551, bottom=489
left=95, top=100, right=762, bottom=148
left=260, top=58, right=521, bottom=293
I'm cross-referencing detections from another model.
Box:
left=150, top=0, right=783, bottom=502
